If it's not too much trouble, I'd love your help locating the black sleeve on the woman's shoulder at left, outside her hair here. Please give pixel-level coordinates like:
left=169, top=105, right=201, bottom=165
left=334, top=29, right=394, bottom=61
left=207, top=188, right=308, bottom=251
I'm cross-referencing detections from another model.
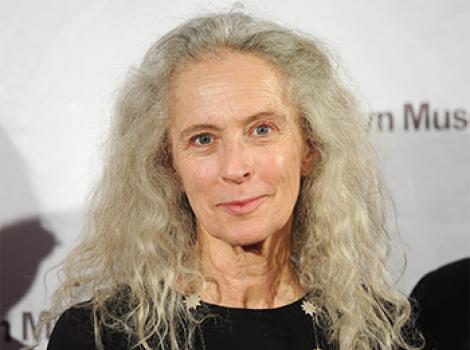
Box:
left=47, top=307, right=96, bottom=350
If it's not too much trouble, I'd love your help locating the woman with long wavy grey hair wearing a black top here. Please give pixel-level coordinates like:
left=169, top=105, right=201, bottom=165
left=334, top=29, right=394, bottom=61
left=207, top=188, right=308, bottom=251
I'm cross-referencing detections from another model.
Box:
left=44, top=13, right=413, bottom=350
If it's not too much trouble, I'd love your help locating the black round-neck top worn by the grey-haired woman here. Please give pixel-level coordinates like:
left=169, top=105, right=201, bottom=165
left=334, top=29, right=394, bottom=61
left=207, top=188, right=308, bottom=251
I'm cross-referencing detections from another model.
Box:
left=47, top=299, right=336, bottom=350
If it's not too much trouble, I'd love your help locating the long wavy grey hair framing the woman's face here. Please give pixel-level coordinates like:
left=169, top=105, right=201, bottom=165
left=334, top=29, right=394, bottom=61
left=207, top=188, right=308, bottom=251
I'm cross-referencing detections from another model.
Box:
left=42, top=12, right=420, bottom=350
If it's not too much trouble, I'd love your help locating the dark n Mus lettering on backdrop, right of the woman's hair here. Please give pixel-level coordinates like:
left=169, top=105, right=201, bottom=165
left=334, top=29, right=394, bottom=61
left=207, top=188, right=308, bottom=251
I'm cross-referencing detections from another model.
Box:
left=368, top=102, right=470, bottom=132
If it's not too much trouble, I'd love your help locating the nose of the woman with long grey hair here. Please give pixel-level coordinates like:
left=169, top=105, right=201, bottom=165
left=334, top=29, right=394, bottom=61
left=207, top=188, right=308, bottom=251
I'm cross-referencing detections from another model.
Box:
left=221, top=140, right=254, bottom=184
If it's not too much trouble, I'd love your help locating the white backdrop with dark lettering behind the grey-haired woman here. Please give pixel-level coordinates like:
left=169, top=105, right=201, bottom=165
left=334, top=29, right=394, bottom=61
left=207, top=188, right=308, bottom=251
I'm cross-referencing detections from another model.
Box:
left=0, top=0, right=470, bottom=348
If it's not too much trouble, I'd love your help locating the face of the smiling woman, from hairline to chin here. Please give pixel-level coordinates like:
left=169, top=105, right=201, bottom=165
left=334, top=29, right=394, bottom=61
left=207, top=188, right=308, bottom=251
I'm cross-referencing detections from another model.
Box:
left=170, top=51, right=313, bottom=246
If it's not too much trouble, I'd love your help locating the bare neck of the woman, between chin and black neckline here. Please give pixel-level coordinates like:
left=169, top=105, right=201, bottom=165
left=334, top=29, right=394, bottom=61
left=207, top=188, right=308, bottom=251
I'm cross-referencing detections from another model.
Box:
left=197, top=220, right=304, bottom=309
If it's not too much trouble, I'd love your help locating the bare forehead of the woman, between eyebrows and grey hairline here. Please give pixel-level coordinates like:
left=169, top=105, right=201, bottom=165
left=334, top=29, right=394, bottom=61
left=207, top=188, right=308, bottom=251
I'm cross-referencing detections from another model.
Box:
left=169, top=51, right=293, bottom=126
